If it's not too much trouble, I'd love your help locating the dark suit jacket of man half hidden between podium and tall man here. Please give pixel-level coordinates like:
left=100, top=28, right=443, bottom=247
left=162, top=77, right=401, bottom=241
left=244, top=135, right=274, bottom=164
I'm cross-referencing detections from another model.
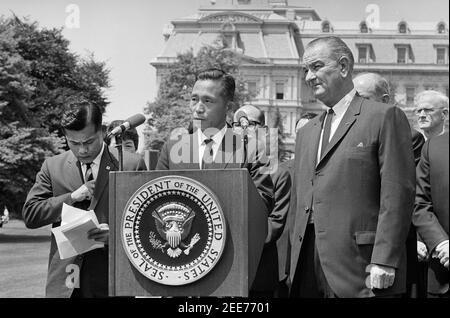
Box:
left=252, top=163, right=291, bottom=292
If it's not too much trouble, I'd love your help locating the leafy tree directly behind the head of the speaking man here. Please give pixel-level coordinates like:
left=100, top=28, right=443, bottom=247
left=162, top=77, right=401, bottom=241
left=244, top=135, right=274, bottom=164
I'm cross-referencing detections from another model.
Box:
left=145, top=40, right=253, bottom=149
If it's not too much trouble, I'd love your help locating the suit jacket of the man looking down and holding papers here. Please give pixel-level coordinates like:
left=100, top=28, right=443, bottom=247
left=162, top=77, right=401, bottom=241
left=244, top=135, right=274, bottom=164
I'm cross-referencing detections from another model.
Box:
left=22, top=146, right=146, bottom=297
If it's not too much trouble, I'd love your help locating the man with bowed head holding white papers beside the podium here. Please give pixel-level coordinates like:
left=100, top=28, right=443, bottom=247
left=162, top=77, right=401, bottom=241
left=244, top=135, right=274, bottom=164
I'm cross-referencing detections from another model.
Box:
left=22, top=101, right=145, bottom=297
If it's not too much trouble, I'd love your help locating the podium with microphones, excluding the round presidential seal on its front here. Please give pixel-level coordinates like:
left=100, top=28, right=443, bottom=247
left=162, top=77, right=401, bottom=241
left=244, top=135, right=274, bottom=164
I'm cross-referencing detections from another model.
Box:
left=109, top=169, right=268, bottom=297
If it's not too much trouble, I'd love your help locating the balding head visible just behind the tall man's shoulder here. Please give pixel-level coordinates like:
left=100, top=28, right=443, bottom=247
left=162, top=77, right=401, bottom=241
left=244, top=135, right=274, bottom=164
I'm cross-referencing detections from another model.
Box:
left=353, top=73, right=389, bottom=104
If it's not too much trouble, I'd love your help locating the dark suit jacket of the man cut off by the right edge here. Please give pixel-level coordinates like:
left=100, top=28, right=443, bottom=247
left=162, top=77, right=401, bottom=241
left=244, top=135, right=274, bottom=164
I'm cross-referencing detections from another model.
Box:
left=413, top=133, right=449, bottom=294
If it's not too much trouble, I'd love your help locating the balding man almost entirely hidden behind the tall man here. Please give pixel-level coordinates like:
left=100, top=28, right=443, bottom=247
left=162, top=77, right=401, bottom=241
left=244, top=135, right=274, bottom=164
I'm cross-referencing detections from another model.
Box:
left=353, top=73, right=426, bottom=298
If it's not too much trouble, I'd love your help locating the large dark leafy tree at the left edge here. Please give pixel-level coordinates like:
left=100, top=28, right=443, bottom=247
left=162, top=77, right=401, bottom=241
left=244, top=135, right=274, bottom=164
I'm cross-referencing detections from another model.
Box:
left=0, top=16, right=109, bottom=214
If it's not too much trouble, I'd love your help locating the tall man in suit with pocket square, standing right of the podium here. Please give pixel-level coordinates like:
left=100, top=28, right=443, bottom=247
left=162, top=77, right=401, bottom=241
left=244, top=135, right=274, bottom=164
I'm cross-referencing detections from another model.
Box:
left=289, top=37, right=415, bottom=298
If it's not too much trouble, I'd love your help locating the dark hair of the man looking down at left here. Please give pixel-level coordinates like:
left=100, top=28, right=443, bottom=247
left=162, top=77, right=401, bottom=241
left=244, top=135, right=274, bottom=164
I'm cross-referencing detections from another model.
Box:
left=61, top=100, right=102, bottom=131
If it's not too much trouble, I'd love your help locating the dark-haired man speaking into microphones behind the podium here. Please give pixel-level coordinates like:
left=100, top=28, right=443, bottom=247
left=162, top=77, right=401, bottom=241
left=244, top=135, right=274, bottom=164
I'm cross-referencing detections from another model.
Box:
left=156, top=69, right=273, bottom=211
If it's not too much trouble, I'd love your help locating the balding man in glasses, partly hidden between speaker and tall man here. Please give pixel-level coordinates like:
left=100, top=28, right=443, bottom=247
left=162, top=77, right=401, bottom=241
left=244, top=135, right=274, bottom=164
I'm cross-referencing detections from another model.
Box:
left=233, top=105, right=291, bottom=297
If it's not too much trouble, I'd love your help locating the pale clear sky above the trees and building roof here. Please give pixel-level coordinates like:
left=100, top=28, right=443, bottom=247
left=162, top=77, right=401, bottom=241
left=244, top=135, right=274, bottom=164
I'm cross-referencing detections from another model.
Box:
left=0, top=0, right=449, bottom=148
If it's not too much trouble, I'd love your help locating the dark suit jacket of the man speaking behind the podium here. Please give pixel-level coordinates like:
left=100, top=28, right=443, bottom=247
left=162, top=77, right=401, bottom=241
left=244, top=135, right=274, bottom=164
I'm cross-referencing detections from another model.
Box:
left=156, top=129, right=273, bottom=211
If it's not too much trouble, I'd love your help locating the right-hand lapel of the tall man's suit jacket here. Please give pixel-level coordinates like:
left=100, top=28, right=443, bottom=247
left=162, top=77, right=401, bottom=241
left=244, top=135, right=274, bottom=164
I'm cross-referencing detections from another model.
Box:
left=316, top=94, right=363, bottom=169
